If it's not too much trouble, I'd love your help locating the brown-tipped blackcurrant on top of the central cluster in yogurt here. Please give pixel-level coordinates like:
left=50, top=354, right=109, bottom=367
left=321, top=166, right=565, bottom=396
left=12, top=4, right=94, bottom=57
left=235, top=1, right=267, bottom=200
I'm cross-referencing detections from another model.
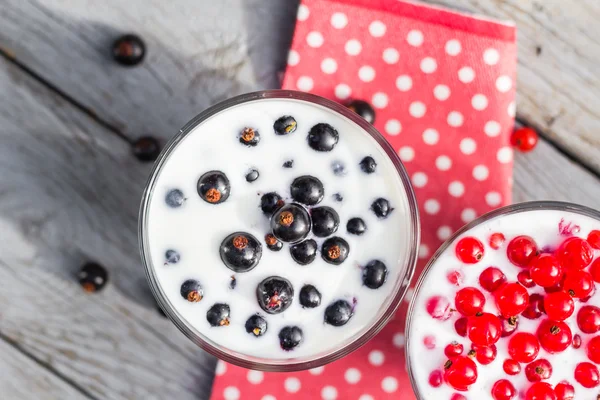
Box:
left=271, top=203, right=310, bottom=243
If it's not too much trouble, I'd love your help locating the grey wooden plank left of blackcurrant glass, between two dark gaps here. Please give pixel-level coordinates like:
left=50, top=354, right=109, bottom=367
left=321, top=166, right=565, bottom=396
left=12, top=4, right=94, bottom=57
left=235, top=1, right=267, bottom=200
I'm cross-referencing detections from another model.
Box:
left=0, top=59, right=214, bottom=399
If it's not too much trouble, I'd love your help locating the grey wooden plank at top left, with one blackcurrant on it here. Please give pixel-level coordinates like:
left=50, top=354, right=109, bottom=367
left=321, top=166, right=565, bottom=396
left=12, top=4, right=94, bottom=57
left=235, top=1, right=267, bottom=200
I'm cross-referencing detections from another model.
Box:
left=0, top=0, right=297, bottom=142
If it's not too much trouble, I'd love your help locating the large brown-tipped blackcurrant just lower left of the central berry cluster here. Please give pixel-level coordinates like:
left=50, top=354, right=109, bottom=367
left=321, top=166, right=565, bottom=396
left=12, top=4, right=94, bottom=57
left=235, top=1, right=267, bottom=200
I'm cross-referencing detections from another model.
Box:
left=219, top=232, right=262, bottom=272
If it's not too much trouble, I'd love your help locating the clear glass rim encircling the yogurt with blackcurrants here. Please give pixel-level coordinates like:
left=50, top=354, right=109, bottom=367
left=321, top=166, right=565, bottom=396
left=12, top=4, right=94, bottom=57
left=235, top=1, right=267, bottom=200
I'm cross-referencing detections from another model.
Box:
left=138, top=90, right=421, bottom=372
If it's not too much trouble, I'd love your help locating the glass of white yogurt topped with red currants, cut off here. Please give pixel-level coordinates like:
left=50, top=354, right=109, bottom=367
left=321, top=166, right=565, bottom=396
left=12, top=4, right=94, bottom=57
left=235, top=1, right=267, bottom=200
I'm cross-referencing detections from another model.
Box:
left=407, top=202, right=600, bottom=400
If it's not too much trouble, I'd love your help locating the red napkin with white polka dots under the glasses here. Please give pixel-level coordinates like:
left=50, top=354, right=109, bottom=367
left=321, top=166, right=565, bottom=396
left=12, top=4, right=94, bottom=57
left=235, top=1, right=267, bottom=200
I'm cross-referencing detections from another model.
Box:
left=212, top=0, right=516, bottom=400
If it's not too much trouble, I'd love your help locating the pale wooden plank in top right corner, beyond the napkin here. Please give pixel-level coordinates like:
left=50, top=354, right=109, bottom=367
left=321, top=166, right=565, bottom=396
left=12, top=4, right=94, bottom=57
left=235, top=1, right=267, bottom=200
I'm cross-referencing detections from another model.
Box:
left=426, top=0, right=600, bottom=174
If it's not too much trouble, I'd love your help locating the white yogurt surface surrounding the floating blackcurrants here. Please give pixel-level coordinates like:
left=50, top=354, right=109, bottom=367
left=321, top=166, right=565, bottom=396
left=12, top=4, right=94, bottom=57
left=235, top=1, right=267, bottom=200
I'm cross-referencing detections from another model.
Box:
left=147, top=99, right=412, bottom=361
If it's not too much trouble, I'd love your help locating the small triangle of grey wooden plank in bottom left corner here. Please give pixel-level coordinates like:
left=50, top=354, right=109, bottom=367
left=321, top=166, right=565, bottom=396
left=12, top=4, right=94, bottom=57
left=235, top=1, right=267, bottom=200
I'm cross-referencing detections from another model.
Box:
left=0, top=340, right=89, bottom=400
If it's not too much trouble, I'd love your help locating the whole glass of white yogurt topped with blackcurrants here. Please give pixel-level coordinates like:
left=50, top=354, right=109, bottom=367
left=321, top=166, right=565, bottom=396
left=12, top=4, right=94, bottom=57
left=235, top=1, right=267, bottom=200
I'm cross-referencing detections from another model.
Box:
left=140, top=91, right=419, bottom=371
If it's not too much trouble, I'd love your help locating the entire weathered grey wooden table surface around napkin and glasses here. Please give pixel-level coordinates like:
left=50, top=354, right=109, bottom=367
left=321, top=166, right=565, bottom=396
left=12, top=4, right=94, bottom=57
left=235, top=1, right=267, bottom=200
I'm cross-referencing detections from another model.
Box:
left=0, top=0, right=600, bottom=399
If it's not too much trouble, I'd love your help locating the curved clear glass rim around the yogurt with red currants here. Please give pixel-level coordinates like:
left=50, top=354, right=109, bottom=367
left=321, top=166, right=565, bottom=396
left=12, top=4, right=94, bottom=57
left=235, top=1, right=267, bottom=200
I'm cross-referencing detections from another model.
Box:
left=404, top=200, right=600, bottom=400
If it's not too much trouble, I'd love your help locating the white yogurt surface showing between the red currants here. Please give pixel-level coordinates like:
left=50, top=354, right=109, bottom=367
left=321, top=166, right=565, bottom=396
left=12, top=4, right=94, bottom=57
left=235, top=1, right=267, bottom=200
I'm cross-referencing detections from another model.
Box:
left=408, top=210, right=600, bottom=400
